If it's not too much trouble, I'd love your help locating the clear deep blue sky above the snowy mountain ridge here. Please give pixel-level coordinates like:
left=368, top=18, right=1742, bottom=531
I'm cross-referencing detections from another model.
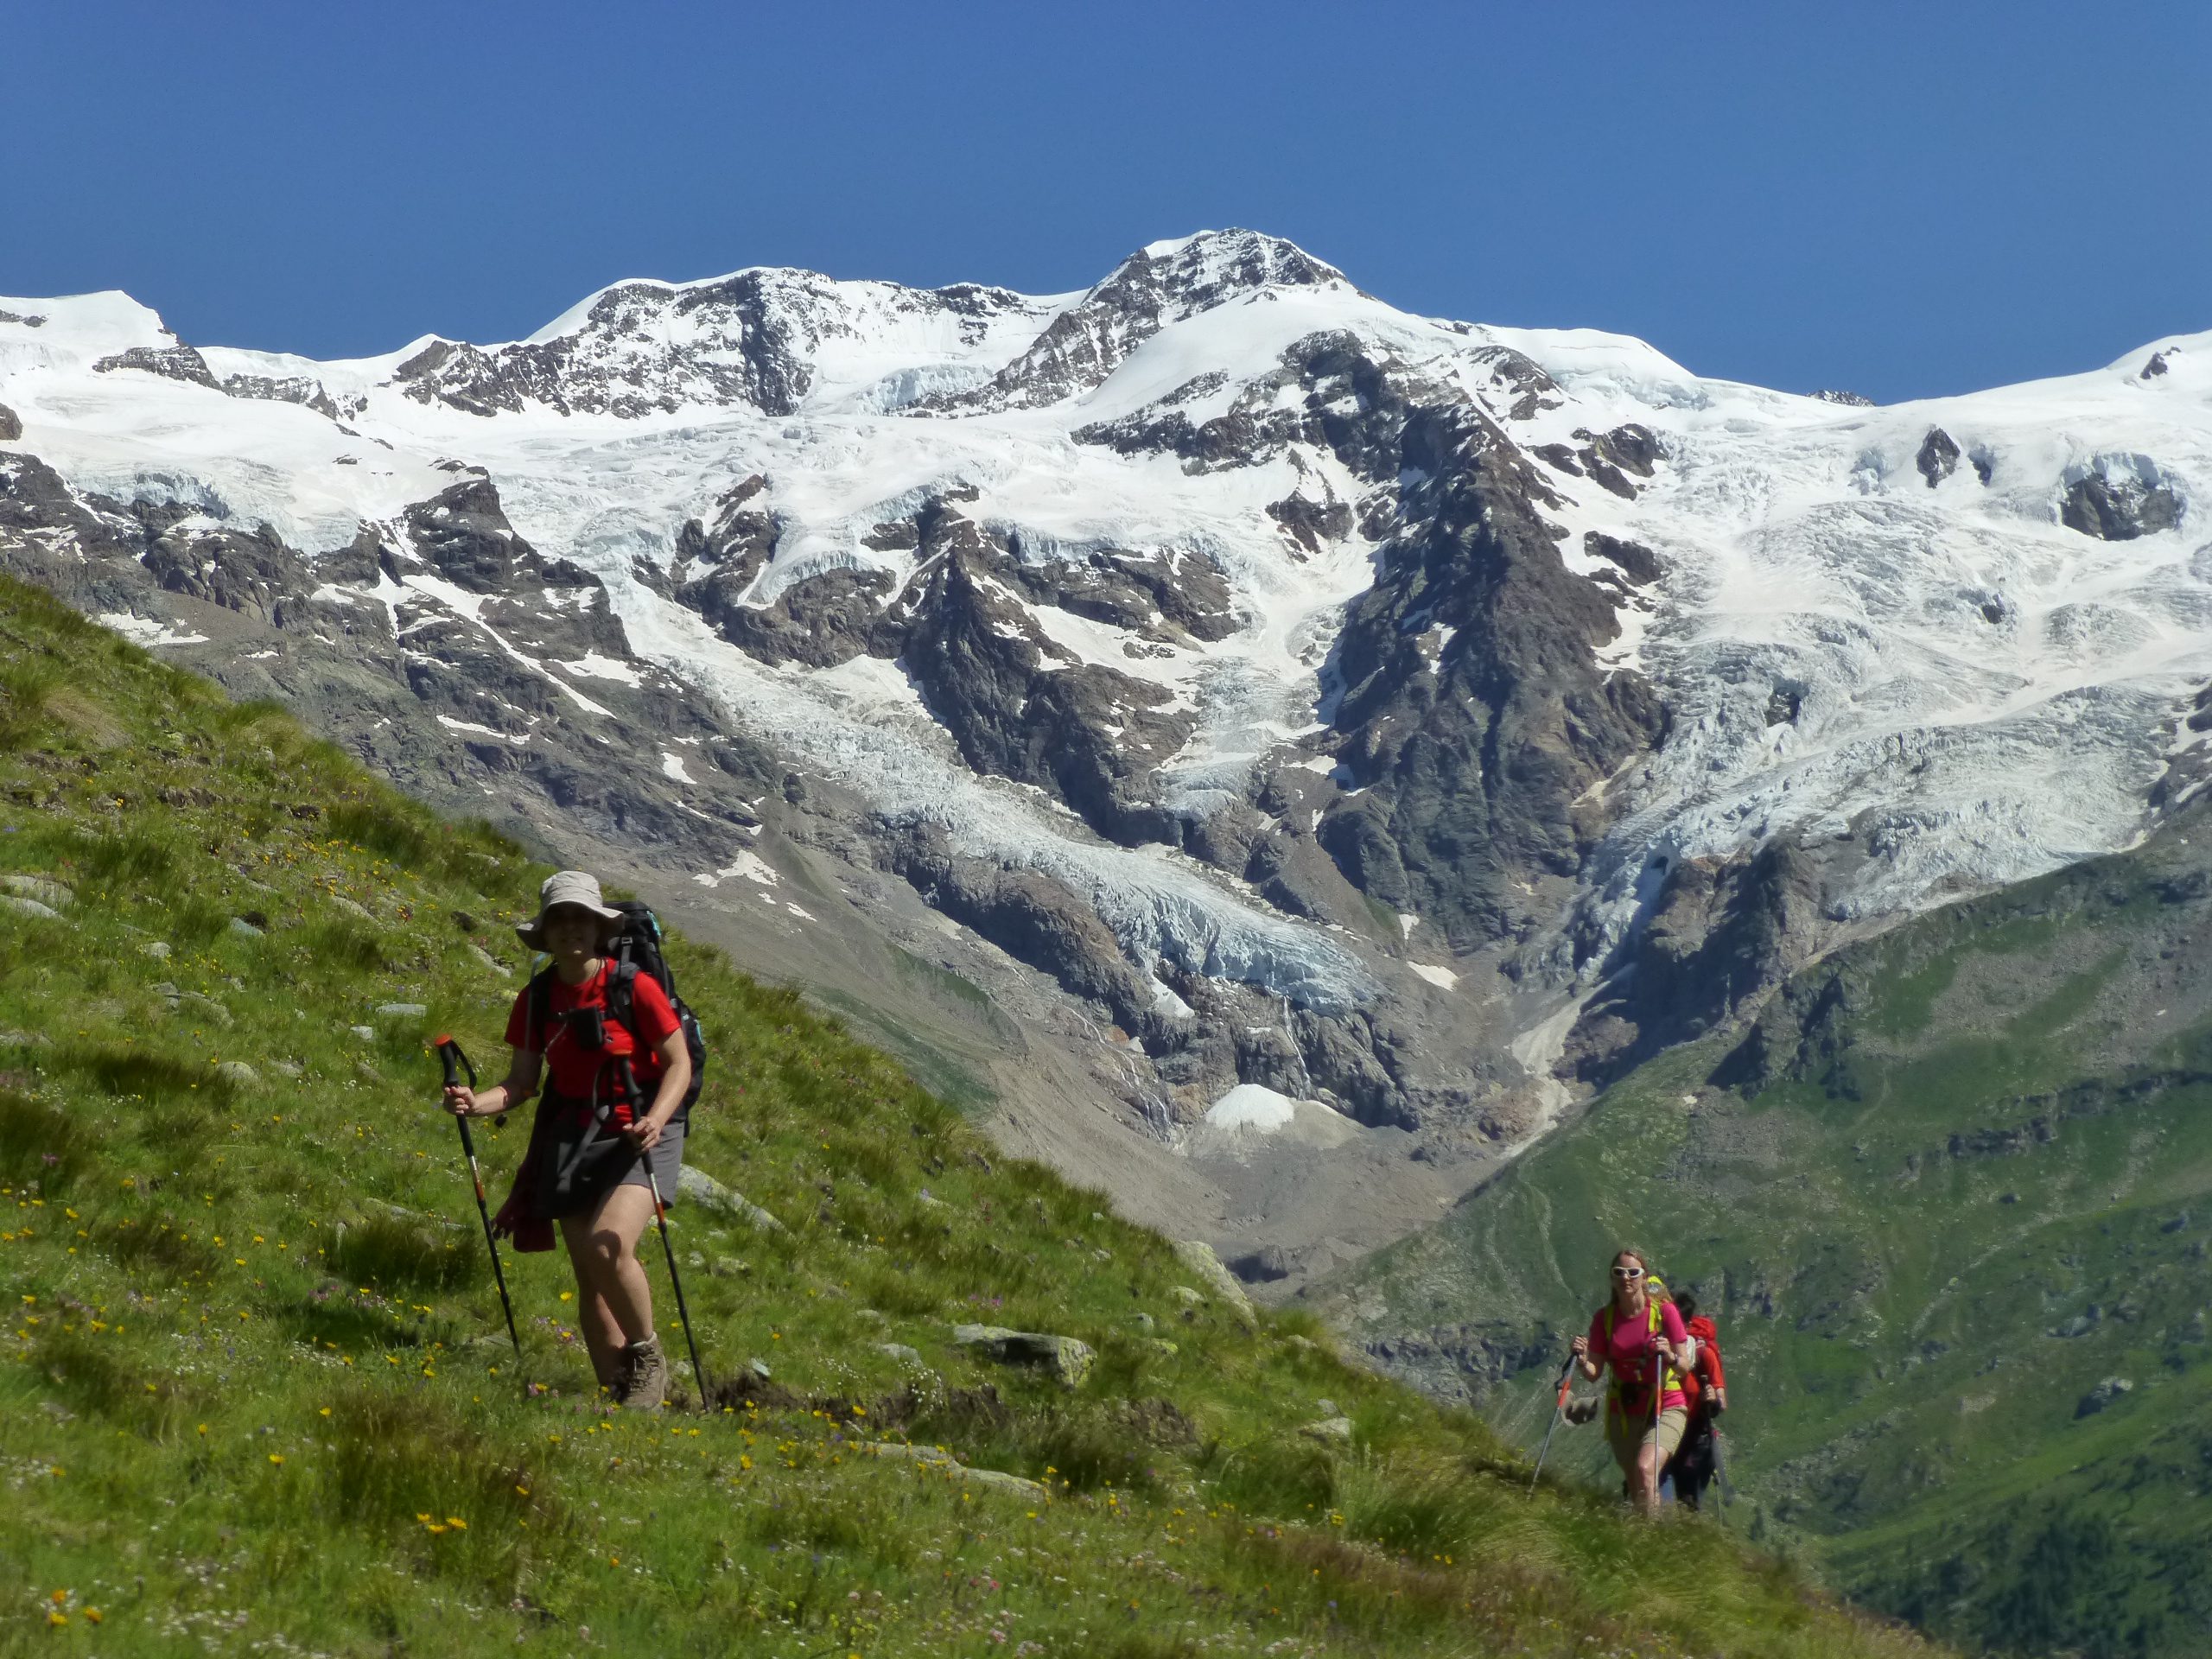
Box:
left=0, top=0, right=2212, bottom=400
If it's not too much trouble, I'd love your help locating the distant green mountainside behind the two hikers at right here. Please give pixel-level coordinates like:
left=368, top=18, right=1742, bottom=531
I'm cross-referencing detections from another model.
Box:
left=1338, top=810, right=2212, bottom=1655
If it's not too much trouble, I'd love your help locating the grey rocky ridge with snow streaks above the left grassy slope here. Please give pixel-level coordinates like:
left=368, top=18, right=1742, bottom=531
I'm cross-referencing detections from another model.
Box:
left=0, top=454, right=767, bottom=858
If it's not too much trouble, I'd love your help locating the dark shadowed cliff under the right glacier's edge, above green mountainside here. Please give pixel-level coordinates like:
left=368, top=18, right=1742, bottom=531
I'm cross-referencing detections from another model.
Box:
left=1568, top=841, right=1821, bottom=1084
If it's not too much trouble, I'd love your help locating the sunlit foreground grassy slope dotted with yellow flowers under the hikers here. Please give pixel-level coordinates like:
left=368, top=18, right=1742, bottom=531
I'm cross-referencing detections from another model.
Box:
left=0, top=584, right=1923, bottom=1655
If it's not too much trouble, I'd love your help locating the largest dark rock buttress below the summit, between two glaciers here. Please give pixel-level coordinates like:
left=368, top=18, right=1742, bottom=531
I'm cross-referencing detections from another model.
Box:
left=1320, top=376, right=1666, bottom=949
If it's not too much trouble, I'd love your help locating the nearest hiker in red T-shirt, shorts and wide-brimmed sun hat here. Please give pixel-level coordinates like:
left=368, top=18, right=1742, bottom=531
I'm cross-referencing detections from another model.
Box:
left=445, top=869, right=692, bottom=1407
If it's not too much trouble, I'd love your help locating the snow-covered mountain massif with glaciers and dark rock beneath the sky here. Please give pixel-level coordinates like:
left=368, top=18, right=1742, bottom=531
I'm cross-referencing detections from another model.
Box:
left=0, top=230, right=2212, bottom=1274
